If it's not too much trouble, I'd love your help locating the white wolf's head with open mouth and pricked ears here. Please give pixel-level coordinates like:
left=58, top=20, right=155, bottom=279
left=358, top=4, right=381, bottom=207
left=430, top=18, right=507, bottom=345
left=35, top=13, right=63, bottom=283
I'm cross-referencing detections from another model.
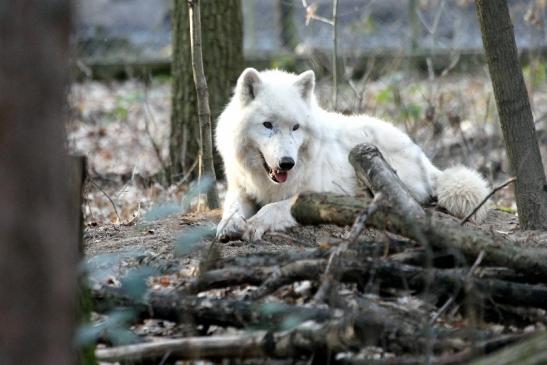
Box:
left=234, top=68, right=315, bottom=184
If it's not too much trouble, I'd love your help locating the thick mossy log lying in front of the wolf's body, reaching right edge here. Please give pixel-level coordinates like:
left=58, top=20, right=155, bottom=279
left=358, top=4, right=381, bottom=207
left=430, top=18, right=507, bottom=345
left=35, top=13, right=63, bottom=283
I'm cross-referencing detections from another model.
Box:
left=291, top=193, right=547, bottom=282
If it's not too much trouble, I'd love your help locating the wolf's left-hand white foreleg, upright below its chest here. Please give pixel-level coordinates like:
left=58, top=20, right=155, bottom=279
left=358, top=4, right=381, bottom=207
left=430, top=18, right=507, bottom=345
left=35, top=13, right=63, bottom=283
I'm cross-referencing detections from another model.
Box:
left=217, top=189, right=256, bottom=241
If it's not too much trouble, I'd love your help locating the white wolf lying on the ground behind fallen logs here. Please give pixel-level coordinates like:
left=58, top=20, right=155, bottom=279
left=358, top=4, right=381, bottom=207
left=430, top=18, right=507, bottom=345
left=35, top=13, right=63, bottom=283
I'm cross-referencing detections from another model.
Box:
left=216, top=68, right=488, bottom=240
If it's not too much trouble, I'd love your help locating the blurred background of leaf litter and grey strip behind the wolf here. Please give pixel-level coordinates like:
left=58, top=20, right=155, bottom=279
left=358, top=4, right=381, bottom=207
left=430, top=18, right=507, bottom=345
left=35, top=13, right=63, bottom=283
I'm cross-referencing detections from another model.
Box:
left=67, top=0, right=547, bottom=225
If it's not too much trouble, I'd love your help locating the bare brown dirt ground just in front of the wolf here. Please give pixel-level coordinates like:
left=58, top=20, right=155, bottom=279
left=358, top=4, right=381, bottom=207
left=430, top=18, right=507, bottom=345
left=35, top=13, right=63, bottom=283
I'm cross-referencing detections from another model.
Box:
left=84, top=202, right=547, bottom=285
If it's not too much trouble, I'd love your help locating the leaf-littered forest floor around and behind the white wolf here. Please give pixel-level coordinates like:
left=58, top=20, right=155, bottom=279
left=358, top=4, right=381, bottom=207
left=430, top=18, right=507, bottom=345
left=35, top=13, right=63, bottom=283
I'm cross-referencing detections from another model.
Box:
left=67, top=75, right=547, bottom=362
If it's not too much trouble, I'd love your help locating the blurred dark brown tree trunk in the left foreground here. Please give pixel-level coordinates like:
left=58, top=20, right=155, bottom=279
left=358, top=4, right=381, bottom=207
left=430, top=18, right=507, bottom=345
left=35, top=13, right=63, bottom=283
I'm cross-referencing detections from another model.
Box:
left=0, top=0, right=78, bottom=365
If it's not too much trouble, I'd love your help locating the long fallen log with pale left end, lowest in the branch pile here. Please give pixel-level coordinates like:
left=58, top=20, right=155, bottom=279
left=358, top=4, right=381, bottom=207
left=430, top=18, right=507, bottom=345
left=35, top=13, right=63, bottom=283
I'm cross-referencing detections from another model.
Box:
left=96, top=308, right=426, bottom=362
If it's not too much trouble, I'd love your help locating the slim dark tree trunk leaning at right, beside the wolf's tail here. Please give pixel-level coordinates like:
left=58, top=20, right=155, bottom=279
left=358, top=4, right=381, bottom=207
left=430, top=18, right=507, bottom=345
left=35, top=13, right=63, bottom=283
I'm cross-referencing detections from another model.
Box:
left=476, top=0, right=547, bottom=229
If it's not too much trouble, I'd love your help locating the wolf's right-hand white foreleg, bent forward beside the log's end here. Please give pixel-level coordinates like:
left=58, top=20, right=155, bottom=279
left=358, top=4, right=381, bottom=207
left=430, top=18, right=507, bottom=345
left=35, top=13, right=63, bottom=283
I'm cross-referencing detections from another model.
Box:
left=243, top=198, right=297, bottom=241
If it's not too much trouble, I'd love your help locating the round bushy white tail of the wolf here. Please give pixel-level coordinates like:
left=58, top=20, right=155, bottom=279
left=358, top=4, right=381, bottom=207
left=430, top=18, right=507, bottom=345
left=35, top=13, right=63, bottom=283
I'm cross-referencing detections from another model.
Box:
left=435, top=166, right=489, bottom=223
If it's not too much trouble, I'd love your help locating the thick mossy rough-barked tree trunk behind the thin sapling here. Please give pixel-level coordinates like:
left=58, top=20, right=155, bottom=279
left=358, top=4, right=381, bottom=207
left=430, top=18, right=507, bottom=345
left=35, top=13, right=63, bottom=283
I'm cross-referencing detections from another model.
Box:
left=167, top=0, right=243, bottom=182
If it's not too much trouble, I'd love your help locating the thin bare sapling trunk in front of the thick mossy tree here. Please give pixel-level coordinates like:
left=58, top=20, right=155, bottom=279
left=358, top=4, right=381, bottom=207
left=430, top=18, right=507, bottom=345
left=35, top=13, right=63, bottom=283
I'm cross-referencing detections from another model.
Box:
left=188, top=0, right=220, bottom=209
